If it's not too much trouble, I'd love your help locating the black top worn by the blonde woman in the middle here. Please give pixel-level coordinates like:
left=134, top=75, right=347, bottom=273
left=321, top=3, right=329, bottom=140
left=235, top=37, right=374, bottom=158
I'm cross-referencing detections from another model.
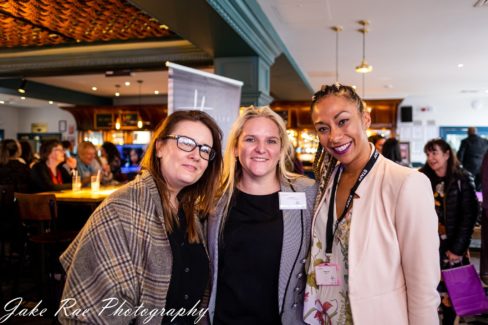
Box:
left=214, top=190, right=283, bottom=325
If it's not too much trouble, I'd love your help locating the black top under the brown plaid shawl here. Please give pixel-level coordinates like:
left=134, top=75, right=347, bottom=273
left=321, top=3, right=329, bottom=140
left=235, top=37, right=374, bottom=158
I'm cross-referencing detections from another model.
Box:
left=162, top=211, right=210, bottom=324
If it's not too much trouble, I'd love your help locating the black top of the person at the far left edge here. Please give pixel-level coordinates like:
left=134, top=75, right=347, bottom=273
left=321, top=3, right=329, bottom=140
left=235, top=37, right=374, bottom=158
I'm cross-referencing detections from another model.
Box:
left=0, top=159, right=32, bottom=193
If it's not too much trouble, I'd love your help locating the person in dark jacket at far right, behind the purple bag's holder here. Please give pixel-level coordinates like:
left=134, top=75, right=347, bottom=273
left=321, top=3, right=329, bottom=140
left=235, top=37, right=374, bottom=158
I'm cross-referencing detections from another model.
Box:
left=457, top=127, right=488, bottom=191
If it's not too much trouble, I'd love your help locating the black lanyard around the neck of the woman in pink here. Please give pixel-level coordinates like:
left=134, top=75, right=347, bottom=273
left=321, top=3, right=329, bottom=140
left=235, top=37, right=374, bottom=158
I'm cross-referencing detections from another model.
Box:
left=325, top=150, right=379, bottom=255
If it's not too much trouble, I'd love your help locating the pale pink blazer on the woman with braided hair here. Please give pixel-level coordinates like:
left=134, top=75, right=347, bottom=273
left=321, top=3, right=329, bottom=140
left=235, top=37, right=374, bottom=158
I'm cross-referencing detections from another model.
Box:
left=314, top=155, right=440, bottom=325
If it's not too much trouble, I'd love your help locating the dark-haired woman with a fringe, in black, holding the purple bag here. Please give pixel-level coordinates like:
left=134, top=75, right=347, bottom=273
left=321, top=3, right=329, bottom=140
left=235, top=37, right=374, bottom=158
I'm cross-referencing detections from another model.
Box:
left=415, top=139, right=479, bottom=325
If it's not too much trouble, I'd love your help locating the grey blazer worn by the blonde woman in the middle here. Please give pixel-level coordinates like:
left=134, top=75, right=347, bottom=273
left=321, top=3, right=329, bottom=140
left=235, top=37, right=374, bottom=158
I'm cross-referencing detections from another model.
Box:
left=207, top=177, right=316, bottom=325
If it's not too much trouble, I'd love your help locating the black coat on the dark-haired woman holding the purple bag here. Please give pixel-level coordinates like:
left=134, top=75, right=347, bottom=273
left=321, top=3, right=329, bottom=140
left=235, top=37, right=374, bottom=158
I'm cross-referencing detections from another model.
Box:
left=420, top=167, right=479, bottom=256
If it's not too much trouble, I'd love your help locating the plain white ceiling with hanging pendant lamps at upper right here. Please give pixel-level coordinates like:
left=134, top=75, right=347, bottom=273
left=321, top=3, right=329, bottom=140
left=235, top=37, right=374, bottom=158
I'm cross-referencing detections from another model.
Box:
left=257, top=0, right=488, bottom=99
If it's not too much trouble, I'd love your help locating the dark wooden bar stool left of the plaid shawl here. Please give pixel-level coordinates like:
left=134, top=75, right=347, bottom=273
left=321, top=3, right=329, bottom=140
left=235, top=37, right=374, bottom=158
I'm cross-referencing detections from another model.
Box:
left=14, top=193, right=78, bottom=310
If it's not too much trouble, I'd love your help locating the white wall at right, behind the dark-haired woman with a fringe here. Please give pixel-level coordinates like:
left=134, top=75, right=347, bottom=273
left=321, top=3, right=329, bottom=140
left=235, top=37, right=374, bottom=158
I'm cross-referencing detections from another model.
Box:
left=397, top=95, right=488, bottom=164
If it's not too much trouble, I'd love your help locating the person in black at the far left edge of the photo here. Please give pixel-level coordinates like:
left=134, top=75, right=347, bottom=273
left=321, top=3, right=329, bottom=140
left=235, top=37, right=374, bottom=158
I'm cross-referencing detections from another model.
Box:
left=0, top=139, right=32, bottom=193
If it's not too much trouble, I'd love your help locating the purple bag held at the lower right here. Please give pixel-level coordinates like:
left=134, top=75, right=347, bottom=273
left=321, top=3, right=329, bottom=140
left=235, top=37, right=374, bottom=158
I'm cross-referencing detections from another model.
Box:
left=442, top=264, right=488, bottom=316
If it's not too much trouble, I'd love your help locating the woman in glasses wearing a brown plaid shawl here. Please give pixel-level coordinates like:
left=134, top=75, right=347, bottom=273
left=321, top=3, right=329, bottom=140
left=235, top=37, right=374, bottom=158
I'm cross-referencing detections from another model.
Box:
left=59, top=111, right=222, bottom=324
